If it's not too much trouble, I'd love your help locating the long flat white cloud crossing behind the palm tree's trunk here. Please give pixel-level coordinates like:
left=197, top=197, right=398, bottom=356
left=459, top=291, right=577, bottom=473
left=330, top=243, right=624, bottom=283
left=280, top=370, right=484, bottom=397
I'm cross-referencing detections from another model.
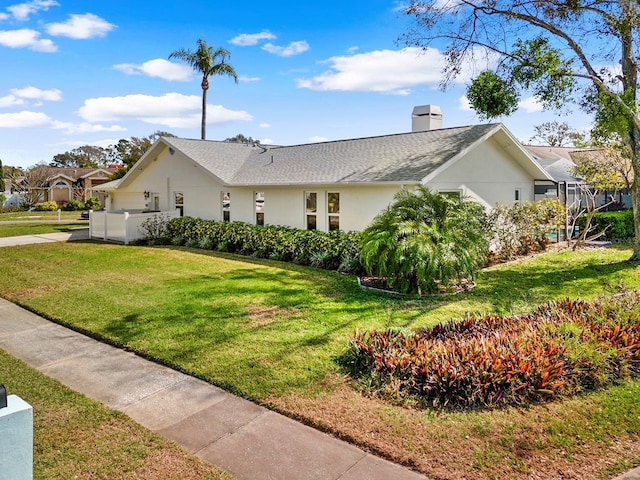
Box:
left=78, top=93, right=253, bottom=128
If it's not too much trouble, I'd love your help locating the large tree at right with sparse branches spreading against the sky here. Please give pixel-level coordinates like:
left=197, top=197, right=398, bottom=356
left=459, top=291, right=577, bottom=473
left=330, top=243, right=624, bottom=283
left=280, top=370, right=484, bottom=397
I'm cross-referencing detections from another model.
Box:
left=405, top=0, right=640, bottom=261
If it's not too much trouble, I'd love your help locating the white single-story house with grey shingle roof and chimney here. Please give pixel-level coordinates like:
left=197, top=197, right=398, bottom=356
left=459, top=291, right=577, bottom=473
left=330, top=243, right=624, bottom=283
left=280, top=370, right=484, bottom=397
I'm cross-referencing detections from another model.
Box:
left=93, top=106, right=553, bottom=242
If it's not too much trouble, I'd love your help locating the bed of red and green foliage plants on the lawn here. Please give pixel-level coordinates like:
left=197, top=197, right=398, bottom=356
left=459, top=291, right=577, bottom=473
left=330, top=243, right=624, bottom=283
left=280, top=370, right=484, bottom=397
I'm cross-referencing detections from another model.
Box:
left=344, top=291, right=640, bottom=408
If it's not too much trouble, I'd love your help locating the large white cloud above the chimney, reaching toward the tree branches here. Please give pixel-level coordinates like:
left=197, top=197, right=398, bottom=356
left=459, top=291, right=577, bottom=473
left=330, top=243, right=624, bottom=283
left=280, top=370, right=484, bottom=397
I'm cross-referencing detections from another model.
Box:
left=296, top=47, right=496, bottom=95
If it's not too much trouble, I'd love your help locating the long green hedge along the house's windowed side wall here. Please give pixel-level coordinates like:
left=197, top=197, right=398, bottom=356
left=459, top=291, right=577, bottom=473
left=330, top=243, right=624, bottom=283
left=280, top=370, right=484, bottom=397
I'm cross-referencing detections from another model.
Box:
left=144, top=217, right=360, bottom=273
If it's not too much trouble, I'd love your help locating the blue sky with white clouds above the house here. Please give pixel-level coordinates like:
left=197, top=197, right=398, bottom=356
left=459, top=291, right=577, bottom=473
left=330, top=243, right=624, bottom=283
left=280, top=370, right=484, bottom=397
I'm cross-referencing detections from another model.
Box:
left=0, top=0, right=588, bottom=167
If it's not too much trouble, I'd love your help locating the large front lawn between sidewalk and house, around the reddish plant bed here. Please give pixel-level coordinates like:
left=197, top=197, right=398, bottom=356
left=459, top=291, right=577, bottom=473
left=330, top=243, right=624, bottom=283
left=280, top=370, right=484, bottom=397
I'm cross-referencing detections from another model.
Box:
left=0, top=243, right=640, bottom=479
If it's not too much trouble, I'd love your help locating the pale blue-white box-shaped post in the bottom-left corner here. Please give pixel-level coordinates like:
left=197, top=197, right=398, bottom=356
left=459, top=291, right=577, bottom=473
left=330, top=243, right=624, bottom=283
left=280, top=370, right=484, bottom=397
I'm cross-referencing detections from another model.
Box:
left=0, top=394, right=33, bottom=480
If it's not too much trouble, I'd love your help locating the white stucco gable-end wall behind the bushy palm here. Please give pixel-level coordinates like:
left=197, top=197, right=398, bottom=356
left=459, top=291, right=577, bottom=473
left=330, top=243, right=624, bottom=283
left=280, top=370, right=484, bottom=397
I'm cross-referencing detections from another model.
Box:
left=427, top=140, right=534, bottom=208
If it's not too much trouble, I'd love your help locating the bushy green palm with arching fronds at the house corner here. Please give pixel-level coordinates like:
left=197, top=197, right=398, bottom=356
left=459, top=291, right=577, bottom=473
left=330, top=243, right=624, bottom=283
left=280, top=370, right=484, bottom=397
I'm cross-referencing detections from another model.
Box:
left=360, top=186, right=489, bottom=294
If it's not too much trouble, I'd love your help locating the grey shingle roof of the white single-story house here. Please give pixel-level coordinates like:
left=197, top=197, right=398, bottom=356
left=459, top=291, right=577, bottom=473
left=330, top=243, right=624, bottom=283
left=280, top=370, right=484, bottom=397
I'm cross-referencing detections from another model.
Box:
left=162, top=124, right=499, bottom=185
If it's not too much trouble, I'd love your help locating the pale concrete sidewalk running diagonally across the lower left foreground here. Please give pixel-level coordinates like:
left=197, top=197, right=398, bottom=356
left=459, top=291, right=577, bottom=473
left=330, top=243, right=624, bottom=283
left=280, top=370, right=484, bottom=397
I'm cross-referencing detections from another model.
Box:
left=0, top=298, right=425, bottom=480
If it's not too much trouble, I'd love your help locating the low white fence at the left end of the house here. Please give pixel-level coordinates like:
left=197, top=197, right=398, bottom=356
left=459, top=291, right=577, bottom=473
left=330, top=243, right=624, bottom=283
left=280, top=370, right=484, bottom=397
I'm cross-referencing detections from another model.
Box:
left=89, top=210, right=180, bottom=245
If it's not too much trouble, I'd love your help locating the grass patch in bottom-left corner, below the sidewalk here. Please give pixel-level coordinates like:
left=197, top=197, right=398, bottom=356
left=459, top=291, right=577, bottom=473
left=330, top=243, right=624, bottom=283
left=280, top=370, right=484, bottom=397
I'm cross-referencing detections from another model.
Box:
left=0, top=350, right=231, bottom=480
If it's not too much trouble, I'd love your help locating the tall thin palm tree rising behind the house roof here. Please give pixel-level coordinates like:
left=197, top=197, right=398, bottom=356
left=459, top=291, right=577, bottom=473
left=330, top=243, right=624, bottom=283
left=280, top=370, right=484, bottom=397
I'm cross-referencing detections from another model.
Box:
left=169, top=38, right=238, bottom=140
